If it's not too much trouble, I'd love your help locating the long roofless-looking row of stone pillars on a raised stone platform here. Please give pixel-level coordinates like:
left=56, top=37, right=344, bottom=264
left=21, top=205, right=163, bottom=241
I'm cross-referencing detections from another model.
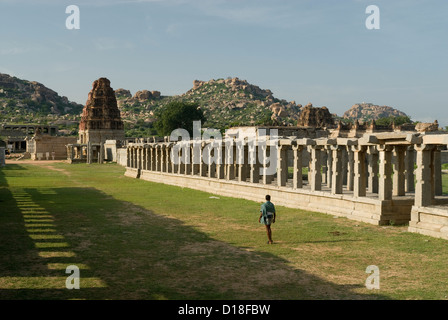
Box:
left=125, top=128, right=448, bottom=239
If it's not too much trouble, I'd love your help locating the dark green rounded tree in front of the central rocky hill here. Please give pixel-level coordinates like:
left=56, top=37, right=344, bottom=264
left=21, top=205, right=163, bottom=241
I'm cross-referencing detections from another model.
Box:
left=154, top=101, right=205, bottom=136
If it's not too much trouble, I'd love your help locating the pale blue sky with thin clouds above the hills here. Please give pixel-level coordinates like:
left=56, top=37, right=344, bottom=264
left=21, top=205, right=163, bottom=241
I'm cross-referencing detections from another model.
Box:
left=0, top=0, right=448, bottom=126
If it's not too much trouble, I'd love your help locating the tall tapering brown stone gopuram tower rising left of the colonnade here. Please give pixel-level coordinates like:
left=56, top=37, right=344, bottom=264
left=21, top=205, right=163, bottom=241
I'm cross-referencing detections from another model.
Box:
left=78, top=78, right=124, bottom=144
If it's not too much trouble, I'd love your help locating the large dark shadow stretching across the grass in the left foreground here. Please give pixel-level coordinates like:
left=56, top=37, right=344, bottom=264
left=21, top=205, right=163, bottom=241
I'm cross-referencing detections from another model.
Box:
left=0, top=165, right=387, bottom=300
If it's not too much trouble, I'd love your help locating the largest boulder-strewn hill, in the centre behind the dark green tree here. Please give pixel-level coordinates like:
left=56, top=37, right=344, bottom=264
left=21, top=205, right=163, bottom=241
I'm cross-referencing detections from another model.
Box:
left=115, top=78, right=302, bottom=128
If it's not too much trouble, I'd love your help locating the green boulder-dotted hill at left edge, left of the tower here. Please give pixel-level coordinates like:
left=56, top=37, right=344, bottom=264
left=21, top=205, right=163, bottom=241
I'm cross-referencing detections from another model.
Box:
left=0, top=73, right=83, bottom=122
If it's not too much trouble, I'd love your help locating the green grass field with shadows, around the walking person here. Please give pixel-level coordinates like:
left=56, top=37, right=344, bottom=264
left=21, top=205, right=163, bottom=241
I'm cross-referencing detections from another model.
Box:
left=0, top=162, right=448, bottom=299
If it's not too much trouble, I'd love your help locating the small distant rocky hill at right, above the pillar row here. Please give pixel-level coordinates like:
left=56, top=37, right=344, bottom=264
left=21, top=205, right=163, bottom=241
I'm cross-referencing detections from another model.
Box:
left=342, top=103, right=408, bottom=121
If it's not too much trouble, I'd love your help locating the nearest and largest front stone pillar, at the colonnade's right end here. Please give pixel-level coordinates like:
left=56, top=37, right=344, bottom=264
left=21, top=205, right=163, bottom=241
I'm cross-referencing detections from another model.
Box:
left=414, top=145, right=433, bottom=207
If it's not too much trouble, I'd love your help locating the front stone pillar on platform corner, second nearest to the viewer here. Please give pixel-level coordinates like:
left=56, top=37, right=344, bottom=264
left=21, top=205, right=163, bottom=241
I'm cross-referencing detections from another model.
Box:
left=378, top=145, right=392, bottom=200
